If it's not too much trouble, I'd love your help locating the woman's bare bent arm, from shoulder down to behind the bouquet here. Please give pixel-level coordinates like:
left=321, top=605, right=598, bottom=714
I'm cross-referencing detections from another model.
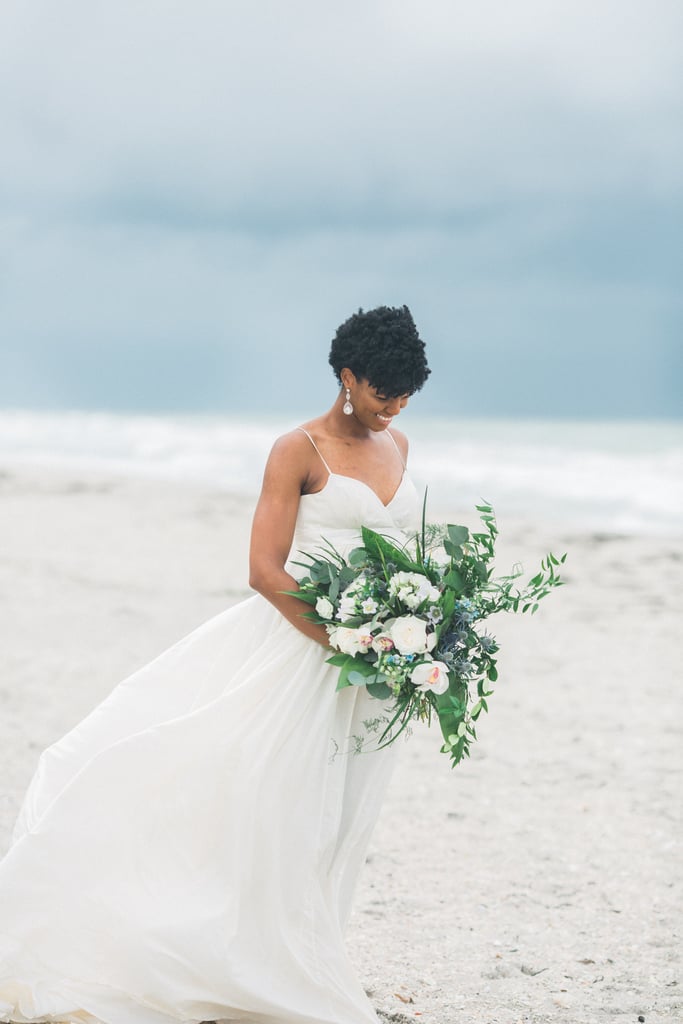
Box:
left=249, top=435, right=329, bottom=647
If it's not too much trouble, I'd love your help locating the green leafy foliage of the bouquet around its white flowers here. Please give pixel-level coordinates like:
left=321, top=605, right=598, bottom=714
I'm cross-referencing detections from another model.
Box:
left=287, top=494, right=566, bottom=766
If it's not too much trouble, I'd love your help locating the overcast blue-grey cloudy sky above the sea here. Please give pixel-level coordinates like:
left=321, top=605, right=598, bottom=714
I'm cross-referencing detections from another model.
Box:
left=0, top=0, right=683, bottom=417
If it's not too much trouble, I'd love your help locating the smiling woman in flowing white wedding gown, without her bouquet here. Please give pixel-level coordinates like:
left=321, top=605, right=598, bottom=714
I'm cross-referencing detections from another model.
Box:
left=0, top=306, right=429, bottom=1024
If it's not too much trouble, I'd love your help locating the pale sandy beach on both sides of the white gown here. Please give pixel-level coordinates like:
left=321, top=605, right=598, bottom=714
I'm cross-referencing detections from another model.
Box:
left=0, top=466, right=683, bottom=1024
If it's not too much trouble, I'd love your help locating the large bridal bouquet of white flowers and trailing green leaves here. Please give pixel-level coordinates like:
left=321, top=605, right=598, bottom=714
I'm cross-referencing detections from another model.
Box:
left=291, top=505, right=566, bottom=767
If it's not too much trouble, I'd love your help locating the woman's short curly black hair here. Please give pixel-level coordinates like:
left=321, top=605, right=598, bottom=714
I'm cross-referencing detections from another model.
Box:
left=330, top=306, right=430, bottom=398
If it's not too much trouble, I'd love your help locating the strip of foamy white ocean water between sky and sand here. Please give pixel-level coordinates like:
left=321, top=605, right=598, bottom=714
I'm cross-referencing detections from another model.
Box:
left=0, top=411, right=683, bottom=536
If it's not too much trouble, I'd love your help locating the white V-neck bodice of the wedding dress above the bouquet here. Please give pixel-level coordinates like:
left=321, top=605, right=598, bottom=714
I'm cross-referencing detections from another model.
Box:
left=287, top=472, right=420, bottom=579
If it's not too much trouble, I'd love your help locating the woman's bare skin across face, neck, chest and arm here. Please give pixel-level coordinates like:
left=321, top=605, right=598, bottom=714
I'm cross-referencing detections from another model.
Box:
left=249, top=369, right=408, bottom=648
